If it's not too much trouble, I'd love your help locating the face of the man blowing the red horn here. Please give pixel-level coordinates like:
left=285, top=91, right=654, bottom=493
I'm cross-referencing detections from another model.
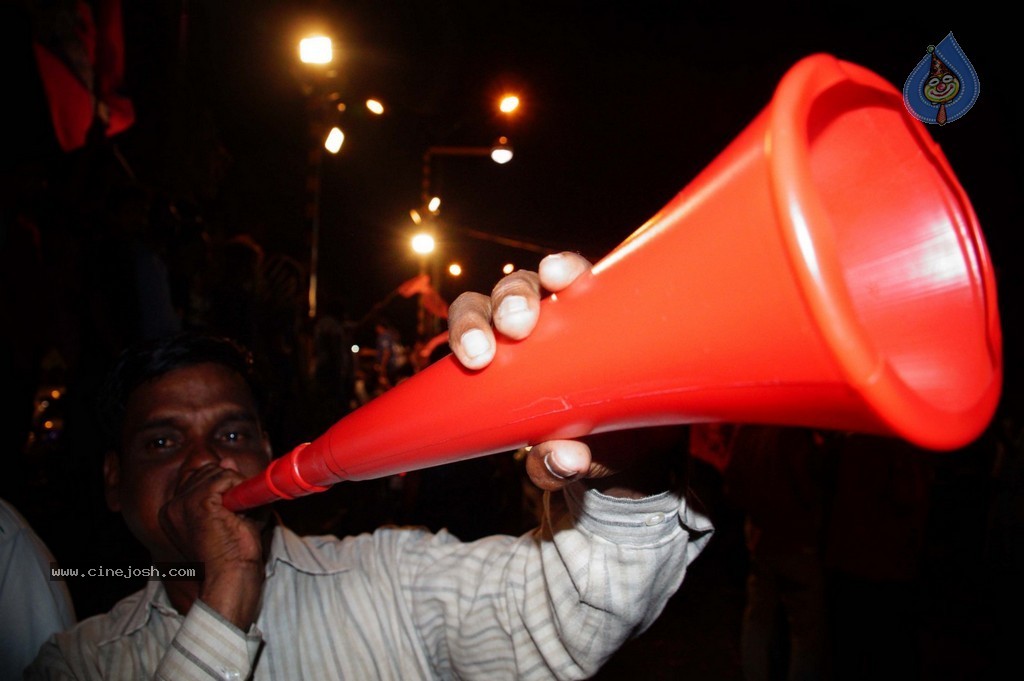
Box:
left=103, top=364, right=270, bottom=560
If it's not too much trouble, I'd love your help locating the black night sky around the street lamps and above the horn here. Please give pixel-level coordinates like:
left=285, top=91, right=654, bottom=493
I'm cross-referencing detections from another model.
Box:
left=4, top=0, right=1024, bottom=368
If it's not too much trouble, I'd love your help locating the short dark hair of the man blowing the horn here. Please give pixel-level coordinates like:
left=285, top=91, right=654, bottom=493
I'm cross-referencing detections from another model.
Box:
left=97, top=332, right=265, bottom=451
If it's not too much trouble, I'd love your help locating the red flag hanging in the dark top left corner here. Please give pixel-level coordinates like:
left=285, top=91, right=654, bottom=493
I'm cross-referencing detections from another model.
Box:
left=33, top=0, right=135, bottom=152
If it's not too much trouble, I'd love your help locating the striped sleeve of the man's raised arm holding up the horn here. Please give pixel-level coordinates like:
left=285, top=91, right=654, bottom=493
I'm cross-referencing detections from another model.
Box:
left=393, top=483, right=711, bottom=679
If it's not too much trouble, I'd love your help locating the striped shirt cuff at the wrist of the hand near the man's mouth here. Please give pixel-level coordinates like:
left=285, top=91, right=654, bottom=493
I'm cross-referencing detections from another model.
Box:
left=157, top=599, right=263, bottom=681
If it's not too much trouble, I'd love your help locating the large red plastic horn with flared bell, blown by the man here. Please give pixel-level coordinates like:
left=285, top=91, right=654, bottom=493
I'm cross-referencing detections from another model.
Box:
left=224, top=54, right=1002, bottom=510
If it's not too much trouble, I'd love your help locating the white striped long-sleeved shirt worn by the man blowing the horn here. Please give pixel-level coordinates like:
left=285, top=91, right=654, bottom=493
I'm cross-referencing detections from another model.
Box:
left=27, top=483, right=711, bottom=681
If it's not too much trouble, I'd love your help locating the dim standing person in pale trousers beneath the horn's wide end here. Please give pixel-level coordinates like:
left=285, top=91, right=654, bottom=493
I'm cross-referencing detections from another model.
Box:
left=725, top=426, right=829, bottom=681
